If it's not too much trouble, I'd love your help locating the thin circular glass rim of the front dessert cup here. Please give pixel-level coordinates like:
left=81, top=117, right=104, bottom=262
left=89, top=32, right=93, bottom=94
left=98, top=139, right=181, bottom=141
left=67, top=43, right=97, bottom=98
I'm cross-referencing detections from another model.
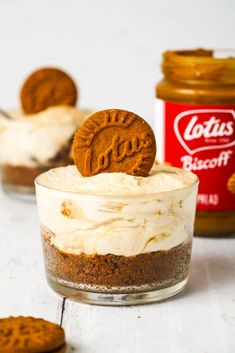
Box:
left=34, top=165, right=199, bottom=200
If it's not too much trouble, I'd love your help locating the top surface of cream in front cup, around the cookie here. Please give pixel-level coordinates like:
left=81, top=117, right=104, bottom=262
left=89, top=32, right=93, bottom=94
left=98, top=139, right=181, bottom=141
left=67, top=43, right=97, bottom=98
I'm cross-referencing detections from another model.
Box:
left=38, top=165, right=196, bottom=195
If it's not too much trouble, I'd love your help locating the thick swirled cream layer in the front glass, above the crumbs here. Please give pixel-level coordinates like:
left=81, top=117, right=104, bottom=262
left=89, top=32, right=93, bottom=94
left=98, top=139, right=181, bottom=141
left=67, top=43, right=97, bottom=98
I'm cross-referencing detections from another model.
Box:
left=36, top=166, right=197, bottom=256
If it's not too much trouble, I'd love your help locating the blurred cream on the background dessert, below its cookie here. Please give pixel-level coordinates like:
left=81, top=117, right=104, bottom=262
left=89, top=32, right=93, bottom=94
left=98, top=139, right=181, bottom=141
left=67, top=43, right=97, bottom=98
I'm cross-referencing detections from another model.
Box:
left=0, top=106, right=87, bottom=167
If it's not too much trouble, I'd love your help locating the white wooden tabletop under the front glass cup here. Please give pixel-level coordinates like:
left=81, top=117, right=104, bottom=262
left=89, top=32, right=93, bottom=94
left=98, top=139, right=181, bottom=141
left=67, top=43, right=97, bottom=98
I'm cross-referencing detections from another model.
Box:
left=0, top=186, right=235, bottom=353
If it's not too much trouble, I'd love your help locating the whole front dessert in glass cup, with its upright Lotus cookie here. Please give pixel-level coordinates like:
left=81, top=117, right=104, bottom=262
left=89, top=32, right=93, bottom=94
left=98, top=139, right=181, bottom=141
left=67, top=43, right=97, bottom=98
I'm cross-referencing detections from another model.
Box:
left=36, top=109, right=198, bottom=305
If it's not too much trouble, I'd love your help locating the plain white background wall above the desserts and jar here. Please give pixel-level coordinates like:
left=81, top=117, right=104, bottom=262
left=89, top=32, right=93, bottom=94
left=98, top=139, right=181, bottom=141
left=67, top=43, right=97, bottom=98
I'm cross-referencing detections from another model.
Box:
left=0, top=0, right=235, bottom=121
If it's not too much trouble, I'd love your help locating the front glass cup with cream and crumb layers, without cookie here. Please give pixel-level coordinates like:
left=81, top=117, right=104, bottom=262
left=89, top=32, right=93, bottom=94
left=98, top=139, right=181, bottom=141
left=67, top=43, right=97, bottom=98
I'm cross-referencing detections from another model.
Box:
left=35, top=167, right=198, bottom=305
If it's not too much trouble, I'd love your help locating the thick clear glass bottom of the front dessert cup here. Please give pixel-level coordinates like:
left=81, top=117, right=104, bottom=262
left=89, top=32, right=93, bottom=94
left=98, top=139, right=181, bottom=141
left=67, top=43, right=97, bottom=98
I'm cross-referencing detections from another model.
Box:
left=47, top=276, right=188, bottom=306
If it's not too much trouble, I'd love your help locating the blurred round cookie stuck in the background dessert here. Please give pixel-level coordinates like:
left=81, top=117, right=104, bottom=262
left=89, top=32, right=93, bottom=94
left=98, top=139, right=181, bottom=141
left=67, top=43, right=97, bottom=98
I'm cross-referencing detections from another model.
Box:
left=20, top=68, right=77, bottom=114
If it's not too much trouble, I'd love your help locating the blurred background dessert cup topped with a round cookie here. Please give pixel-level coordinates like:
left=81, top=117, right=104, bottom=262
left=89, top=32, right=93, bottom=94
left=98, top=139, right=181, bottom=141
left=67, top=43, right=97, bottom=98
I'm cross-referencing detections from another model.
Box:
left=0, top=68, right=91, bottom=197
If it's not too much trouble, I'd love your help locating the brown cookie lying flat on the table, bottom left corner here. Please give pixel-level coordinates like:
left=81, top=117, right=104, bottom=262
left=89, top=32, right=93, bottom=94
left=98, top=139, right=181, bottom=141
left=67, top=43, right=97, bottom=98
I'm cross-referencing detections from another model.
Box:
left=0, top=316, right=66, bottom=353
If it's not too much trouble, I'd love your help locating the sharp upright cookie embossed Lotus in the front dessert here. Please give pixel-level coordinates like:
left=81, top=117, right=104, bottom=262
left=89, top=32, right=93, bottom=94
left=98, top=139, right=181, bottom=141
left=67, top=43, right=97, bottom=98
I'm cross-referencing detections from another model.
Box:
left=73, top=109, right=156, bottom=176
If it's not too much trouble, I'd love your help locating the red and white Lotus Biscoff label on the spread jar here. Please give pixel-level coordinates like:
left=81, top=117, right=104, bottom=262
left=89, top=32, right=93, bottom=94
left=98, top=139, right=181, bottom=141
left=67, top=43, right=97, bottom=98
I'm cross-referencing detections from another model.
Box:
left=155, top=100, right=235, bottom=211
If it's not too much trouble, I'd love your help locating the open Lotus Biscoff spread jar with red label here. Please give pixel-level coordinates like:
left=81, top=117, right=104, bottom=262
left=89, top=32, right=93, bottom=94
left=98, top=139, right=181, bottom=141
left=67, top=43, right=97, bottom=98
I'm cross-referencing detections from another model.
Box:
left=155, top=49, right=235, bottom=235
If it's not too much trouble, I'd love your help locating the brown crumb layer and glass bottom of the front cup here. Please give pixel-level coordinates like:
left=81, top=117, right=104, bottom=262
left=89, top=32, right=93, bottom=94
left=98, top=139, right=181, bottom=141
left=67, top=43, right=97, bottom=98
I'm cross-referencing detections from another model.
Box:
left=42, top=227, right=192, bottom=305
